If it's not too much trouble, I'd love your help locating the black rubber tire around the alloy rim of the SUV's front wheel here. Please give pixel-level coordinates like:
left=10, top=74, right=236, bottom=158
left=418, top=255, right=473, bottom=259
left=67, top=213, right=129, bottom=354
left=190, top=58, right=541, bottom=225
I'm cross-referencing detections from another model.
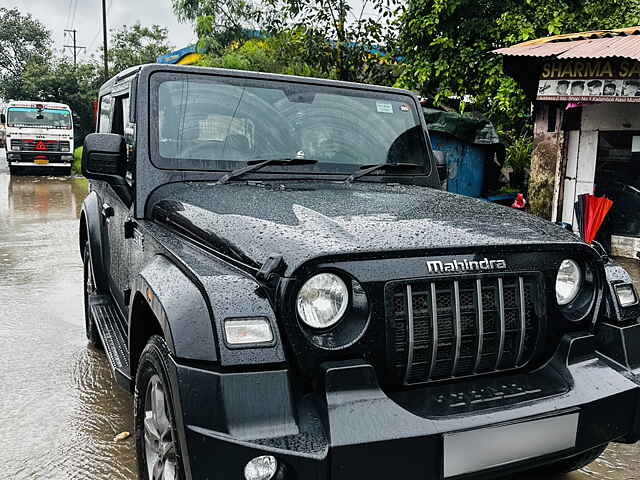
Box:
left=133, top=335, right=185, bottom=480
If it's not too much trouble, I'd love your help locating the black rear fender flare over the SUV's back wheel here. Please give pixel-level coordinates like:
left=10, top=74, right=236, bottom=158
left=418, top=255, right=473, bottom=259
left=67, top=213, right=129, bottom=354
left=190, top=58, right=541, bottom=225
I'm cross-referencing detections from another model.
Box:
left=80, top=191, right=109, bottom=293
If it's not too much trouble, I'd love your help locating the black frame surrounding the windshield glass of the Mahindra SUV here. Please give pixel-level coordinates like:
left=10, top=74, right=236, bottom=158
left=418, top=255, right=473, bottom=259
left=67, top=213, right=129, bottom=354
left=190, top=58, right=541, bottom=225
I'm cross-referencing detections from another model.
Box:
left=148, top=73, right=435, bottom=179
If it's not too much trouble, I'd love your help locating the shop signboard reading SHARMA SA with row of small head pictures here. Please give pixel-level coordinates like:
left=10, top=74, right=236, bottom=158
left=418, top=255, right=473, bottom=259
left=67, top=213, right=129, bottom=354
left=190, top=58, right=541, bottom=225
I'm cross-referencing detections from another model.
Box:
left=537, top=60, right=640, bottom=102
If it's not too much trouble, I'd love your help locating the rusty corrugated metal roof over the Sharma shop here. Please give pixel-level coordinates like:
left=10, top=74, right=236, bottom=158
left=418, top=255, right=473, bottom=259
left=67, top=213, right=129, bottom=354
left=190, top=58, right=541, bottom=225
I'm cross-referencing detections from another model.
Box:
left=494, top=27, right=640, bottom=61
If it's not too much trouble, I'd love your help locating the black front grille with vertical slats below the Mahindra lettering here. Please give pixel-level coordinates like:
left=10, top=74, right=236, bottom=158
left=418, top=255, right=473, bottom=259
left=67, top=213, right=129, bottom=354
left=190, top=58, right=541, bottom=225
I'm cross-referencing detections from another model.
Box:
left=385, top=274, right=541, bottom=385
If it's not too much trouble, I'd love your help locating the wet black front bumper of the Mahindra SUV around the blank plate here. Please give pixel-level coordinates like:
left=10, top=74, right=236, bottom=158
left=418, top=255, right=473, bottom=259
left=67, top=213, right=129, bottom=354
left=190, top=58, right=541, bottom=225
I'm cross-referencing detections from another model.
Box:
left=169, top=335, right=640, bottom=480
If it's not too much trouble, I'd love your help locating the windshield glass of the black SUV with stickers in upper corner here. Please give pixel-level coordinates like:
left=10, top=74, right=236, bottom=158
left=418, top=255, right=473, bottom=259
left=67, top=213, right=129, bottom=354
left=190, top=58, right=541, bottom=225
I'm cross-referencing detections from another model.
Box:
left=153, top=75, right=428, bottom=172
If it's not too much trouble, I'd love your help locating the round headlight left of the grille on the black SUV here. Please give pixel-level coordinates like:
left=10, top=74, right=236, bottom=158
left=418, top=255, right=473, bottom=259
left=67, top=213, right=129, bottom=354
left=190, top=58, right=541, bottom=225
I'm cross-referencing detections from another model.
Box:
left=296, top=273, right=349, bottom=328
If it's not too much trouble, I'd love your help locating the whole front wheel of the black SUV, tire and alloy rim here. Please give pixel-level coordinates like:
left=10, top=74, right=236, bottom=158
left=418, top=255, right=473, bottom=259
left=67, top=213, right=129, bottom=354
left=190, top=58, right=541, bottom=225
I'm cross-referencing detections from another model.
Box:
left=134, top=335, right=185, bottom=480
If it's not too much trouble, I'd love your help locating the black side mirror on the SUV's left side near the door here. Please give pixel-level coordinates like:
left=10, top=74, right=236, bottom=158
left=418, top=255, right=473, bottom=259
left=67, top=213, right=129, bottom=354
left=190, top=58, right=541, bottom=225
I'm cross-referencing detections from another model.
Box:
left=82, top=133, right=127, bottom=185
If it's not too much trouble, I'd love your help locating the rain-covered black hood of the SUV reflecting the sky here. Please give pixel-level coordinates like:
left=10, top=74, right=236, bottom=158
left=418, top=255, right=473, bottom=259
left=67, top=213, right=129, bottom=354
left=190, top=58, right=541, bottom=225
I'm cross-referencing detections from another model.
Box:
left=153, top=182, right=581, bottom=273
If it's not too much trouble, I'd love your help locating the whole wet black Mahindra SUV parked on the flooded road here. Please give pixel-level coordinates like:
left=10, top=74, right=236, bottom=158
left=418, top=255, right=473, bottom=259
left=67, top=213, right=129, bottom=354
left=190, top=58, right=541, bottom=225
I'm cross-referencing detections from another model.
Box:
left=79, top=65, right=640, bottom=480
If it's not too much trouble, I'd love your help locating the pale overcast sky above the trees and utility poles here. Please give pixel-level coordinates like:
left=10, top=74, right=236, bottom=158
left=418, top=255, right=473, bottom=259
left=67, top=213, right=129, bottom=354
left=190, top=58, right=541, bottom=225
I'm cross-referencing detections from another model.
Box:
left=0, top=0, right=376, bottom=59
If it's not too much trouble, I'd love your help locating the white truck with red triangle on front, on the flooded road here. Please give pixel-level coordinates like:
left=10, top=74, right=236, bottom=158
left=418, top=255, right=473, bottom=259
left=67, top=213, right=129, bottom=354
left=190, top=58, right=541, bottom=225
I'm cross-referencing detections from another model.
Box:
left=0, top=101, right=73, bottom=175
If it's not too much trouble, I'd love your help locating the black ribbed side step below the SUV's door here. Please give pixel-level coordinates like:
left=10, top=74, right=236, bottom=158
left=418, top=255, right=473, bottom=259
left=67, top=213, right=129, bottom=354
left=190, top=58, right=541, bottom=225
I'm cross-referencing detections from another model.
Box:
left=89, top=295, right=133, bottom=391
